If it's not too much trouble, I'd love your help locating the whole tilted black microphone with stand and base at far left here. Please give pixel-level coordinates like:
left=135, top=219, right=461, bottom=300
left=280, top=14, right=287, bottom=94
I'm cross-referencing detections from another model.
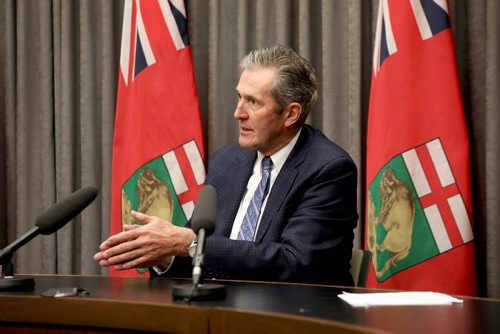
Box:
left=0, top=186, right=99, bottom=291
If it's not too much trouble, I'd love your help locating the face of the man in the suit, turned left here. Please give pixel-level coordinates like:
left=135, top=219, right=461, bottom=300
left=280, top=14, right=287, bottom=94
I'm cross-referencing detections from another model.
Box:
left=234, top=68, right=289, bottom=156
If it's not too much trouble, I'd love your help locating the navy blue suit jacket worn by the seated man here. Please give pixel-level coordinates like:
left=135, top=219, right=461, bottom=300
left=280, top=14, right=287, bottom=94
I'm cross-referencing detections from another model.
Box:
left=158, top=125, right=358, bottom=285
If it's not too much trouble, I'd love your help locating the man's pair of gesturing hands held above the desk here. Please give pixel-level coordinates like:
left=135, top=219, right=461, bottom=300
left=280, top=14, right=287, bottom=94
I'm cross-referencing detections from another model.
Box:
left=94, top=211, right=195, bottom=270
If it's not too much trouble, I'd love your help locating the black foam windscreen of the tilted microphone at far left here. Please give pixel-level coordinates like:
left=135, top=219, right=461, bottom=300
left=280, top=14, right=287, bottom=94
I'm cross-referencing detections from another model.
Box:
left=35, top=187, right=99, bottom=235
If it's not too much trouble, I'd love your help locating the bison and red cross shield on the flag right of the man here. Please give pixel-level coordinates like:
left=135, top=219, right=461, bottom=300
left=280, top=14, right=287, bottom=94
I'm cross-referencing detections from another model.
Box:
left=367, top=139, right=473, bottom=282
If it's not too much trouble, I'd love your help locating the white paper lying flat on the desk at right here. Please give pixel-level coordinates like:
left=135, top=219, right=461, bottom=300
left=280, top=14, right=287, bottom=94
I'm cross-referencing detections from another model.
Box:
left=338, top=291, right=463, bottom=306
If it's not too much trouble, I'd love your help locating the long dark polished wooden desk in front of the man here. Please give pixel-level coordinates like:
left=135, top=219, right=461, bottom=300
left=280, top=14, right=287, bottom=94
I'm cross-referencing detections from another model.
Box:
left=0, top=275, right=500, bottom=334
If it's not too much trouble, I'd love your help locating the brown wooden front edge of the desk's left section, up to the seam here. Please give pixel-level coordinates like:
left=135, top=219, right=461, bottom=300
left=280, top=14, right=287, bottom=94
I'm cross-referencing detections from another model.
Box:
left=0, top=296, right=209, bottom=334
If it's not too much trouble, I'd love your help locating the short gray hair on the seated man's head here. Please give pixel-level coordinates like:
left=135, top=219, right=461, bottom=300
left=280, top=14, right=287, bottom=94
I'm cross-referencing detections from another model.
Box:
left=240, top=45, right=318, bottom=124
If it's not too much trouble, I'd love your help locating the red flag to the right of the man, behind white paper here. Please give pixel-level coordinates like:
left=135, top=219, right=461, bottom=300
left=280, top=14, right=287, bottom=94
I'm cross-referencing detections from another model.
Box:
left=365, top=0, right=476, bottom=295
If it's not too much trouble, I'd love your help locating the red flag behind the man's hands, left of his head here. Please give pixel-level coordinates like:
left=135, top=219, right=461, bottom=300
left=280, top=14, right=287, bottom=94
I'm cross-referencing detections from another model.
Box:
left=110, top=0, right=205, bottom=275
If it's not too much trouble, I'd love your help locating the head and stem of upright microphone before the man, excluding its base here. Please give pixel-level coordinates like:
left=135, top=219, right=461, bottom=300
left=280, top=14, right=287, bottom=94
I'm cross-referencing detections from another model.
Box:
left=191, top=185, right=217, bottom=285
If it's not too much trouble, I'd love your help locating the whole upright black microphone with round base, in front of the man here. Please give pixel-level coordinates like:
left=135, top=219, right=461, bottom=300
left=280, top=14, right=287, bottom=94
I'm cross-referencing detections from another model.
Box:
left=173, top=185, right=226, bottom=304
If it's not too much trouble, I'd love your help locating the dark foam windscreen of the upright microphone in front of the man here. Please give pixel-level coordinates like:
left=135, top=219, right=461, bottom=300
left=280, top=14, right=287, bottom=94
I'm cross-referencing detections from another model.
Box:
left=191, top=185, right=217, bottom=236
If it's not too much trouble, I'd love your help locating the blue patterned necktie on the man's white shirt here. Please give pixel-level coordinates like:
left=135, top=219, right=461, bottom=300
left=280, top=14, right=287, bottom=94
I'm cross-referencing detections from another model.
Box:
left=238, top=157, right=273, bottom=241
